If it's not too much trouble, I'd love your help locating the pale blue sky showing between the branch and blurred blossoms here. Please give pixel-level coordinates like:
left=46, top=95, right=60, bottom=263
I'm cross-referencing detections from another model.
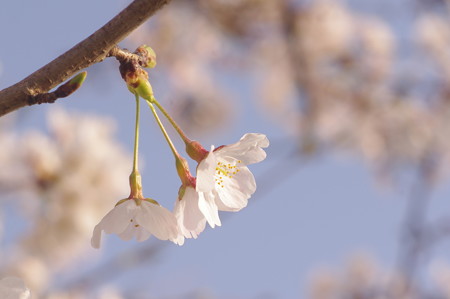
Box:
left=0, top=0, right=450, bottom=298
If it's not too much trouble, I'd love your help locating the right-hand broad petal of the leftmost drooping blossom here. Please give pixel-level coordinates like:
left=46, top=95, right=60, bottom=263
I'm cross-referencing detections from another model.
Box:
left=135, top=201, right=178, bottom=240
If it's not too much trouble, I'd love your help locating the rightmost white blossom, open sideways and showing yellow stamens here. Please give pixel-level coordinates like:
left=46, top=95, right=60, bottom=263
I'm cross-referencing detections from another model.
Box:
left=196, top=133, right=269, bottom=227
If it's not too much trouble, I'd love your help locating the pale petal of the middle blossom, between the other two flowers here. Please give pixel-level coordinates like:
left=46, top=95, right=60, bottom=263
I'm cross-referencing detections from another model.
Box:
left=174, top=187, right=206, bottom=239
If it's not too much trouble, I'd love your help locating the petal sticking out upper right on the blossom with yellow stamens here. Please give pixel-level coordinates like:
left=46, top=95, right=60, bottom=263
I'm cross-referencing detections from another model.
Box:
left=215, top=133, right=269, bottom=165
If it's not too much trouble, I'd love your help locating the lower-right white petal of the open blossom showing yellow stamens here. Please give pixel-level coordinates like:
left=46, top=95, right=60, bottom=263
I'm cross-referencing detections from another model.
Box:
left=216, top=167, right=256, bottom=211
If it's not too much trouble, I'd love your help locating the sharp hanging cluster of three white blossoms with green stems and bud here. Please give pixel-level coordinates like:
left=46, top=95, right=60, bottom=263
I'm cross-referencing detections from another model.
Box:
left=91, top=46, right=269, bottom=248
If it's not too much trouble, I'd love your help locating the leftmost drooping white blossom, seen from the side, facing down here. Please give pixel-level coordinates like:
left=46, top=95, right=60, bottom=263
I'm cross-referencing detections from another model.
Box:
left=91, top=199, right=182, bottom=248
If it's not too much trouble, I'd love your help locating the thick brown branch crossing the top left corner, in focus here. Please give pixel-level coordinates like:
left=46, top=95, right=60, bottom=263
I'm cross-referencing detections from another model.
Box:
left=0, top=0, right=170, bottom=116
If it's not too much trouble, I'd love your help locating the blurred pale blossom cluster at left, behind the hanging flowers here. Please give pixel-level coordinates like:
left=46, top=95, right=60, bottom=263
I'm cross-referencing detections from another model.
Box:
left=0, top=108, right=130, bottom=298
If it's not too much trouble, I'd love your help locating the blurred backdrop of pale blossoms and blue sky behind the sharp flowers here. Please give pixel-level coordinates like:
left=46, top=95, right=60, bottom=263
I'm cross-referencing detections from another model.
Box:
left=0, top=0, right=450, bottom=299
